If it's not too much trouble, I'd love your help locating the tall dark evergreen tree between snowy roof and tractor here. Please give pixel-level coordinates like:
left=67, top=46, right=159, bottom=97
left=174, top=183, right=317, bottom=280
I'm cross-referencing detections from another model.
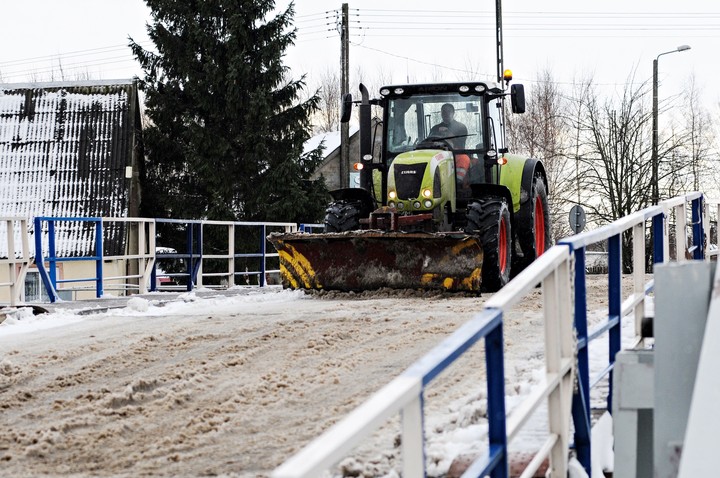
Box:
left=130, top=0, right=327, bottom=222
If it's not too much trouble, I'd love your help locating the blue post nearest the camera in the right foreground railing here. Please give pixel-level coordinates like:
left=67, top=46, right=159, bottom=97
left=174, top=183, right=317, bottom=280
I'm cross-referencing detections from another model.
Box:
left=485, top=322, right=509, bottom=478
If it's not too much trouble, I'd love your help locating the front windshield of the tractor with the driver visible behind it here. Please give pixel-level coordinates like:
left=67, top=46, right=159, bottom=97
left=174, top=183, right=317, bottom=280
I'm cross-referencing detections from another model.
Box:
left=387, top=93, right=485, bottom=156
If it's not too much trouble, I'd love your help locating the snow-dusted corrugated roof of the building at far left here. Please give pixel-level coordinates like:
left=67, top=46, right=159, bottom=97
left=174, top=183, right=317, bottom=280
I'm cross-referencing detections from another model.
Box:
left=0, top=80, right=137, bottom=256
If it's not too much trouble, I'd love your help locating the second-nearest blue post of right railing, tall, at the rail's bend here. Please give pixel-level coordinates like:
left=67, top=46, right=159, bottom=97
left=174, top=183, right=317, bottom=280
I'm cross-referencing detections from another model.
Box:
left=572, top=247, right=592, bottom=476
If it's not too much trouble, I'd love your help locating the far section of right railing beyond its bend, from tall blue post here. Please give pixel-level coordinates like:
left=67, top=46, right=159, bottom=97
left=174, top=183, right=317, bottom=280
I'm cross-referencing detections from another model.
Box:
left=560, top=193, right=704, bottom=474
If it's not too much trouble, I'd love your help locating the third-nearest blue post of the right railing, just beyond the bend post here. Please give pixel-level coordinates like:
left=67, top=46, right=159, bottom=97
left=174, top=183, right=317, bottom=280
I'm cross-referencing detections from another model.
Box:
left=607, top=233, right=622, bottom=413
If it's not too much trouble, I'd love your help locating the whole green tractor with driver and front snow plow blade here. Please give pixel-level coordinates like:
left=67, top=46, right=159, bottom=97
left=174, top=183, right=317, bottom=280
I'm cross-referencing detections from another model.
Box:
left=269, top=72, right=551, bottom=292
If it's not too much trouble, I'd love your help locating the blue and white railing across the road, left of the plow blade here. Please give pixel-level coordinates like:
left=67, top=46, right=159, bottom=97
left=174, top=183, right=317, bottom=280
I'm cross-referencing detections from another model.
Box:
left=31, top=217, right=298, bottom=302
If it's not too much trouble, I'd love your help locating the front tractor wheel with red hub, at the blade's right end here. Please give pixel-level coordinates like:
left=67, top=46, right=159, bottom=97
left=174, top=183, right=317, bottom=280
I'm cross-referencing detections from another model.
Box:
left=465, top=197, right=512, bottom=292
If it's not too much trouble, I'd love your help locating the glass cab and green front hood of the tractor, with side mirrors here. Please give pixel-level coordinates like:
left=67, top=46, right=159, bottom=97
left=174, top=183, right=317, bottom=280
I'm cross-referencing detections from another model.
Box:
left=352, top=82, right=524, bottom=219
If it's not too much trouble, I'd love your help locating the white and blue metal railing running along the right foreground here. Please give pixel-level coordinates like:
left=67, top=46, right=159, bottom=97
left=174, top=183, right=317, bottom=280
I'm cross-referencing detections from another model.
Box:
left=272, top=193, right=705, bottom=478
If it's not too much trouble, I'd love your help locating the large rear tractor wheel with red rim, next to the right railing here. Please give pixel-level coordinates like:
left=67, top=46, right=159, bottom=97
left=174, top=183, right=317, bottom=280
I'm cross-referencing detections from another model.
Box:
left=513, top=174, right=552, bottom=275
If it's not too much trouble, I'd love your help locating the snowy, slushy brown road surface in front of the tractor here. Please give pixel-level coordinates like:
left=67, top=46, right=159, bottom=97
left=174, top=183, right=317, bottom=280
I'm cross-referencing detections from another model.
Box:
left=0, top=276, right=632, bottom=477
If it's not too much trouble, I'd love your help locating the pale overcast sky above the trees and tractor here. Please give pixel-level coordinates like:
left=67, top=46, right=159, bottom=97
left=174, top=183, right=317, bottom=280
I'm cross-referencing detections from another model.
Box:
left=0, top=0, right=720, bottom=102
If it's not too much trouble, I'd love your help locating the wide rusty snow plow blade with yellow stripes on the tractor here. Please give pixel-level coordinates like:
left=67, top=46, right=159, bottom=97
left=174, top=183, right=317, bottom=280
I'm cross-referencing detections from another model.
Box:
left=268, top=230, right=483, bottom=292
